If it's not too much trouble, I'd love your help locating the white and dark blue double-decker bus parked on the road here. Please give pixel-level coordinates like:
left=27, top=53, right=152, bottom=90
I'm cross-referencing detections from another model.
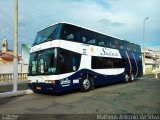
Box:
left=28, top=23, right=143, bottom=92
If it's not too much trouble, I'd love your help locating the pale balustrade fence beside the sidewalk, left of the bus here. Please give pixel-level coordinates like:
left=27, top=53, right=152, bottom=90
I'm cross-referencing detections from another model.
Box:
left=0, top=73, right=27, bottom=82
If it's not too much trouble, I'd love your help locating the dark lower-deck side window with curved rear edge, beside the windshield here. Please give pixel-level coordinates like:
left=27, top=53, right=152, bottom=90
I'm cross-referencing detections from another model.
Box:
left=58, top=49, right=81, bottom=74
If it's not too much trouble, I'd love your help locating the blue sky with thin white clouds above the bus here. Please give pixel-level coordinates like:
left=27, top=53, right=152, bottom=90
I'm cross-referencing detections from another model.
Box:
left=0, top=0, right=160, bottom=52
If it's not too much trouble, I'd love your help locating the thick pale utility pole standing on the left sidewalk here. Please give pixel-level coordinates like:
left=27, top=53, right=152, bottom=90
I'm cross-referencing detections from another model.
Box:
left=13, top=0, right=18, bottom=92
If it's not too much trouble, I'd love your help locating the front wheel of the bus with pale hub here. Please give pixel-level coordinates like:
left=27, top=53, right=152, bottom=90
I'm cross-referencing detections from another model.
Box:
left=80, top=77, right=92, bottom=92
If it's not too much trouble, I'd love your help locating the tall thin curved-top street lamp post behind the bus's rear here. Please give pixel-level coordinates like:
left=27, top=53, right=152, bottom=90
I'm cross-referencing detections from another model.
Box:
left=143, top=17, right=149, bottom=74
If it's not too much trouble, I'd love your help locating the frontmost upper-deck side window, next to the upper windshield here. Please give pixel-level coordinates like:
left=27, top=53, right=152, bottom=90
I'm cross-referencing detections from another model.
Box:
left=61, top=25, right=79, bottom=42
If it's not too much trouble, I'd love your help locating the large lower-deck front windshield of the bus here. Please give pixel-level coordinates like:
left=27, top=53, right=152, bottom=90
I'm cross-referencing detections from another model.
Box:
left=29, top=48, right=57, bottom=75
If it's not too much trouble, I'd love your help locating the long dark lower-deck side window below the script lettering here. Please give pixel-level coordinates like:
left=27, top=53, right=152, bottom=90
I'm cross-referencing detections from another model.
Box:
left=92, top=57, right=125, bottom=69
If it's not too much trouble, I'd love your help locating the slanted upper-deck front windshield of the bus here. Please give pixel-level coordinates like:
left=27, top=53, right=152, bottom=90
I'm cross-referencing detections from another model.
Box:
left=33, top=25, right=59, bottom=45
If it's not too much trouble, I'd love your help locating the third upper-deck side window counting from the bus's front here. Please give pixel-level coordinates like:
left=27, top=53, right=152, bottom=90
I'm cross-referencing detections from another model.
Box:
left=97, top=34, right=110, bottom=47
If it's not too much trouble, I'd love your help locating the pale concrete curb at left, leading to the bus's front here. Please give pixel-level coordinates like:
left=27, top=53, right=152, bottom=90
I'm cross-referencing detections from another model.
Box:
left=0, top=89, right=33, bottom=98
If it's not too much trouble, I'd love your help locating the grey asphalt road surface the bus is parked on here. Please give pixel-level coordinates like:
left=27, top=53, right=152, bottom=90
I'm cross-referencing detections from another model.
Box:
left=0, top=76, right=160, bottom=118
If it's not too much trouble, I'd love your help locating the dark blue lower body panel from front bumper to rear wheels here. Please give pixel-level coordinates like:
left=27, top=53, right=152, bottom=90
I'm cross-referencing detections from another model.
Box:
left=28, top=69, right=124, bottom=92
